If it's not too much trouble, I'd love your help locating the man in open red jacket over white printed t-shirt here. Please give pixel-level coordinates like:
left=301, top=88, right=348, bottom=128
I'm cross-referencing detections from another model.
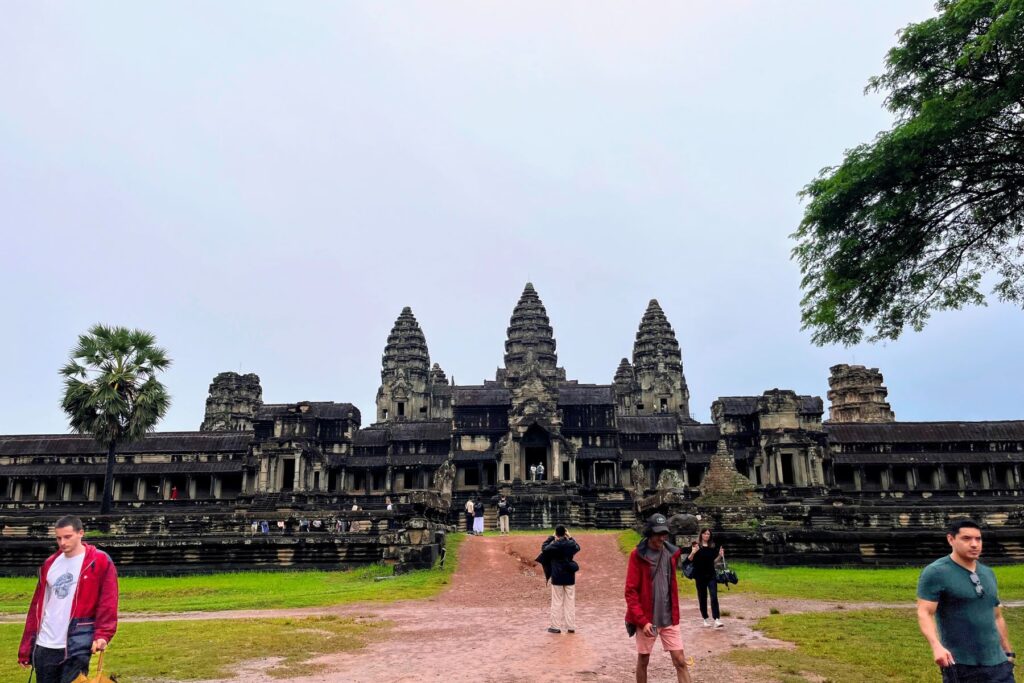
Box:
left=17, top=516, right=118, bottom=683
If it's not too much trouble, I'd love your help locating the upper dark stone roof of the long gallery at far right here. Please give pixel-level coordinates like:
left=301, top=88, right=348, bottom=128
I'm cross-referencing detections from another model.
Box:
left=822, top=420, right=1024, bottom=446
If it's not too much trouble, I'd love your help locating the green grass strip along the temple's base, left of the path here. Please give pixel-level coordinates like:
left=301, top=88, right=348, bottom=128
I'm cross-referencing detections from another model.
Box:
left=0, top=533, right=466, bottom=618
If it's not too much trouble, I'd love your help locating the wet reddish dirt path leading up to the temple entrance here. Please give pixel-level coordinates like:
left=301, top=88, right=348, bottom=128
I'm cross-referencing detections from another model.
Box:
left=193, top=532, right=784, bottom=683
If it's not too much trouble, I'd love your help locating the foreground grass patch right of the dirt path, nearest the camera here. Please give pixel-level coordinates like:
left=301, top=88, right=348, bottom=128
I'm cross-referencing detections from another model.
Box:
left=727, top=609, right=1024, bottom=683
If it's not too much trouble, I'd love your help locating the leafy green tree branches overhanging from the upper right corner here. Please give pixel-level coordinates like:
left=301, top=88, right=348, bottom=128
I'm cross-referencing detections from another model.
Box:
left=793, top=0, right=1024, bottom=344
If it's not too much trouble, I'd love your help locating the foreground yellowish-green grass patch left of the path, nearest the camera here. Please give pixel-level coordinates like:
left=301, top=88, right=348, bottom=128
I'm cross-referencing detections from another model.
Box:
left=0, top=616, right=386, bottom=683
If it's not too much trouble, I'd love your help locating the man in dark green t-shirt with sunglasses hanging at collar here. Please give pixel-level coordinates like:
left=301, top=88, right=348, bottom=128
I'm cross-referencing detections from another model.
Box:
left=918, top=519, right=1016, bottom=683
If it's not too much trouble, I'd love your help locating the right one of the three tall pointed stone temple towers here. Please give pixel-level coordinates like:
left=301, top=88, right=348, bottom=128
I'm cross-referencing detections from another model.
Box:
left=633, top=299, right=690, bottom=420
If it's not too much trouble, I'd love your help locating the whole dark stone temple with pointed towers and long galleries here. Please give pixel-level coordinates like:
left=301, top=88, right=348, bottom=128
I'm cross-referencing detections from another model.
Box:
left=0, top=284, right=1024, bottom=559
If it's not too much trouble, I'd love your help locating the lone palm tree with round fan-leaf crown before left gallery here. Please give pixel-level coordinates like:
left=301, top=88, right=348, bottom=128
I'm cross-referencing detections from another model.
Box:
left=60, top=325, right=171, bottom=515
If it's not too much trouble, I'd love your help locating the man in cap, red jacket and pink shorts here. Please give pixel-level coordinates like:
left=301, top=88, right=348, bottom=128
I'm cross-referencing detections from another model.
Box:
left=626, top=514, right=690, bottom=683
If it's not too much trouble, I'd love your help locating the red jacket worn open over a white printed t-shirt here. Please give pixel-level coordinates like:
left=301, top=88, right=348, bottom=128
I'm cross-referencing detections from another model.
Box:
left=17, top=543, right=118, bottom=664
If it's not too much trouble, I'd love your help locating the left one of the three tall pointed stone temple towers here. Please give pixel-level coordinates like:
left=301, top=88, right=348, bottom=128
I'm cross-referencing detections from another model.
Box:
left=377, top=306, right=434, bottom=422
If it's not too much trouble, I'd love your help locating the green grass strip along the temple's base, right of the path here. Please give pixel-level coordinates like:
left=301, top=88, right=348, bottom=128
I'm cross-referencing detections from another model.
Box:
left=618, top=530, right=1024, bottom=604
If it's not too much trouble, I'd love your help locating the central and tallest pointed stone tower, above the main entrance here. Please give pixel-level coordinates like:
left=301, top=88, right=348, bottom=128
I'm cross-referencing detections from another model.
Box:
left=498, top=283, right=565, bottom=386
